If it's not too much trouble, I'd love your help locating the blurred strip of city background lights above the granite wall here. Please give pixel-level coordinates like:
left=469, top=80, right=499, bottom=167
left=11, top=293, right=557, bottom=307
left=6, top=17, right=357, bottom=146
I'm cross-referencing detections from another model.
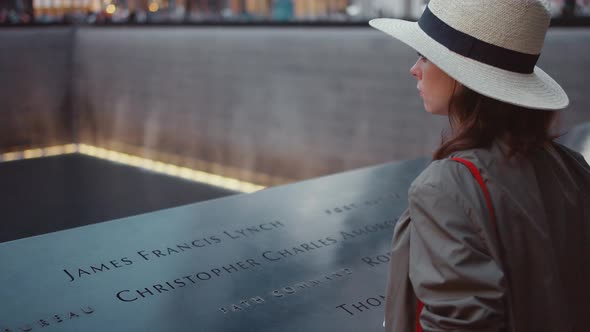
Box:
left=0, top=0, right=590, bottom=24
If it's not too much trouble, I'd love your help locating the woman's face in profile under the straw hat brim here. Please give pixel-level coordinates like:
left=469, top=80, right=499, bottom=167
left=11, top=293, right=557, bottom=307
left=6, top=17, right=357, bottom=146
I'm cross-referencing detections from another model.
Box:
left=410, top=54, right=459, bottom=115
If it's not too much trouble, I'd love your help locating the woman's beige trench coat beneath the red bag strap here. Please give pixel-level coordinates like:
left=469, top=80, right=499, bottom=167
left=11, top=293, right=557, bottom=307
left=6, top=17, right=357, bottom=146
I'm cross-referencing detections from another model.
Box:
left=385, top=142, right=590, bottom=332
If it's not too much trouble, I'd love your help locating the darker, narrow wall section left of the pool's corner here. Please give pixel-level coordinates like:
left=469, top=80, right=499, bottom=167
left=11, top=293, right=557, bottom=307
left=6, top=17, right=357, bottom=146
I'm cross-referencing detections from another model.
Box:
left=0, top=27, right=74, bottom=151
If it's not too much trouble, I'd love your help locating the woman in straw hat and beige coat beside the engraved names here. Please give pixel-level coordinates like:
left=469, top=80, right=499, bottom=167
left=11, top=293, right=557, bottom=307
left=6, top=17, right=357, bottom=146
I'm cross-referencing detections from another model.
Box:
left=370, top=0, right=590, bottom=332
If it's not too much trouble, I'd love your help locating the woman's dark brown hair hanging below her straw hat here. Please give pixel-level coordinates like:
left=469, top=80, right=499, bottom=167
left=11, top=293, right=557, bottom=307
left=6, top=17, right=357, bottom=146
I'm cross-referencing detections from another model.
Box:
left=433, top=82, right=560, bottom=160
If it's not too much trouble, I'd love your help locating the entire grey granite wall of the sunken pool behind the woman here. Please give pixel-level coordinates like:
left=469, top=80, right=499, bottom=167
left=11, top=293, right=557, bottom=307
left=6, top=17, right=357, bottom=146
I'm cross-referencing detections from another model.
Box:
left=0, top=27, right=590, bottom=184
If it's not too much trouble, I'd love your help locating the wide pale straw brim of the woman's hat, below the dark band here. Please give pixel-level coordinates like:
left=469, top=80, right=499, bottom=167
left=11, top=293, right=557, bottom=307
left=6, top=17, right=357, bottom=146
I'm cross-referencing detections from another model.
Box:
left=369, top=18, right=569, bottom=111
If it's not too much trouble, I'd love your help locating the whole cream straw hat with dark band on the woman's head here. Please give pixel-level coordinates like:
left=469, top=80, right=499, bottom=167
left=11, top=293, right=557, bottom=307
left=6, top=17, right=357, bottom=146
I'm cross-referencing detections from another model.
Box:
left=369, top=0, right=569, bottom=110
